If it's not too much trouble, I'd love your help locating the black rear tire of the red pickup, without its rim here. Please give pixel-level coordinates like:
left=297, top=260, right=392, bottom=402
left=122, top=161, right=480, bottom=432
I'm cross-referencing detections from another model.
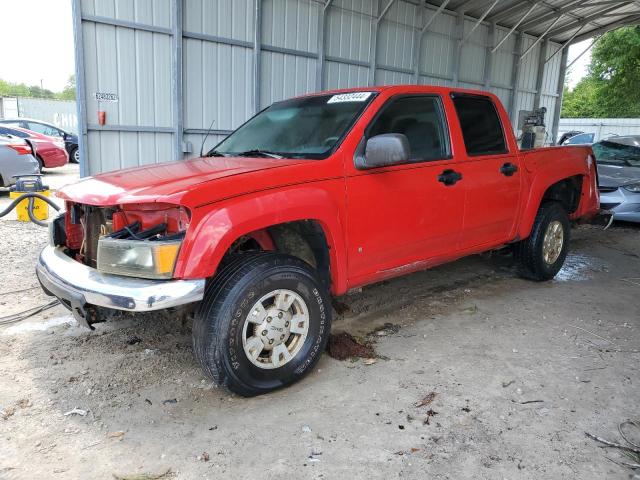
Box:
left=514, top=202, right=571, bottom=281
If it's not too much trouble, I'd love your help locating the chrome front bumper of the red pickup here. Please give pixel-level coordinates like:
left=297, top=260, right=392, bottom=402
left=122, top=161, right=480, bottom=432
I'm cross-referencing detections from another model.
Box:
left=36, top=245, right=205, bottom=328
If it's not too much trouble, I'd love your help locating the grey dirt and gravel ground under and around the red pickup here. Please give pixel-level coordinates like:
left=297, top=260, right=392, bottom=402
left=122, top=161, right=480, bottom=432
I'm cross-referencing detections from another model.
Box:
left=0, top=198, right=640, bottom=479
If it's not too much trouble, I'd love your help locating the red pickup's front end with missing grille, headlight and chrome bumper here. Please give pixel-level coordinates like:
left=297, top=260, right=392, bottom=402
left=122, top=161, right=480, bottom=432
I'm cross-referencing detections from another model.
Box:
left=36, top=202, right=204, bottom=328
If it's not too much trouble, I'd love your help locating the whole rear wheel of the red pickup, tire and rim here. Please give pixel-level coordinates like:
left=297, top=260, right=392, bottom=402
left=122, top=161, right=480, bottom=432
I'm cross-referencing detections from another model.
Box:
left=515, top=202, right=571, bottom=281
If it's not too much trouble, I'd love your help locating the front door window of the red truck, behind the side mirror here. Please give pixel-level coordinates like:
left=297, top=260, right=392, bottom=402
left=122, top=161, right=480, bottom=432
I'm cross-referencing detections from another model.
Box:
left=367, top=95, right=450, bottom=162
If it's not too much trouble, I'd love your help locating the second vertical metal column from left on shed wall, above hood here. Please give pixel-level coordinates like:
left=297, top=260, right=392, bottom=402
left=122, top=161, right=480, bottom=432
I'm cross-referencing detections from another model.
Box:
left=171, top=0, right=184, bottom=160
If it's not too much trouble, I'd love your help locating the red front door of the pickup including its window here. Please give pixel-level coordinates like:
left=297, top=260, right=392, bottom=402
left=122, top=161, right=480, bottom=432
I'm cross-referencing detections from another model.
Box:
left=347, top=94, right=464, bottom=284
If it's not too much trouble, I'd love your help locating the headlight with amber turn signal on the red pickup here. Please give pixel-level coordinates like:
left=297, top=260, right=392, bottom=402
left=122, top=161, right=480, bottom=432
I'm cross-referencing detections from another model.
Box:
left=97, top=237, right=182, bottom=280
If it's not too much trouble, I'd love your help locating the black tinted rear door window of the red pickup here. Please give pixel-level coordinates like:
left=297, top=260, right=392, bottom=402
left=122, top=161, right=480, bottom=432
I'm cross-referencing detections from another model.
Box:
left=452, top=94, right=508, bottom=156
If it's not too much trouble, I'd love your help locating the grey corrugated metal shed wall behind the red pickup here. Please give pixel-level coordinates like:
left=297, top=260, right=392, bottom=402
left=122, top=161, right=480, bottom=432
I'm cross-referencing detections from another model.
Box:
left=73, top=0, right=564, bottom=174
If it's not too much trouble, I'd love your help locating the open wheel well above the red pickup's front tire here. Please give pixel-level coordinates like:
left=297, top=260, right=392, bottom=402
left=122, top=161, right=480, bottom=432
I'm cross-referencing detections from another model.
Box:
left=222, top=220, right=331, bottom=289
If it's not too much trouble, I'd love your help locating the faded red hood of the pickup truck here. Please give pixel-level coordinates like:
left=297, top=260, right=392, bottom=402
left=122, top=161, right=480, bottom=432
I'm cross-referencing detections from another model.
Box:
left=57, top=157, right=304, bottom=205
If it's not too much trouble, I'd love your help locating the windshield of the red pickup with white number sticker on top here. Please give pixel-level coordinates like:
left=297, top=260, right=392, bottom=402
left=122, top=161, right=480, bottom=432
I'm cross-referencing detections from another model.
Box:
left=207, top=92, right=374, bottom=158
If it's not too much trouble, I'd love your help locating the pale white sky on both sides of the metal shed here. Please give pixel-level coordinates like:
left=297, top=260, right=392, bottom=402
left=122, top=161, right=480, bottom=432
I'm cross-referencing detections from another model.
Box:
left=0, top=0, right=591, bottom=92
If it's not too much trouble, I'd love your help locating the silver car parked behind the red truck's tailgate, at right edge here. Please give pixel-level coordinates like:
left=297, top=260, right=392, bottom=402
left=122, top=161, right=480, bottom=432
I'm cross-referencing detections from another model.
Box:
left=591, top=135, right=640, bottom=222
